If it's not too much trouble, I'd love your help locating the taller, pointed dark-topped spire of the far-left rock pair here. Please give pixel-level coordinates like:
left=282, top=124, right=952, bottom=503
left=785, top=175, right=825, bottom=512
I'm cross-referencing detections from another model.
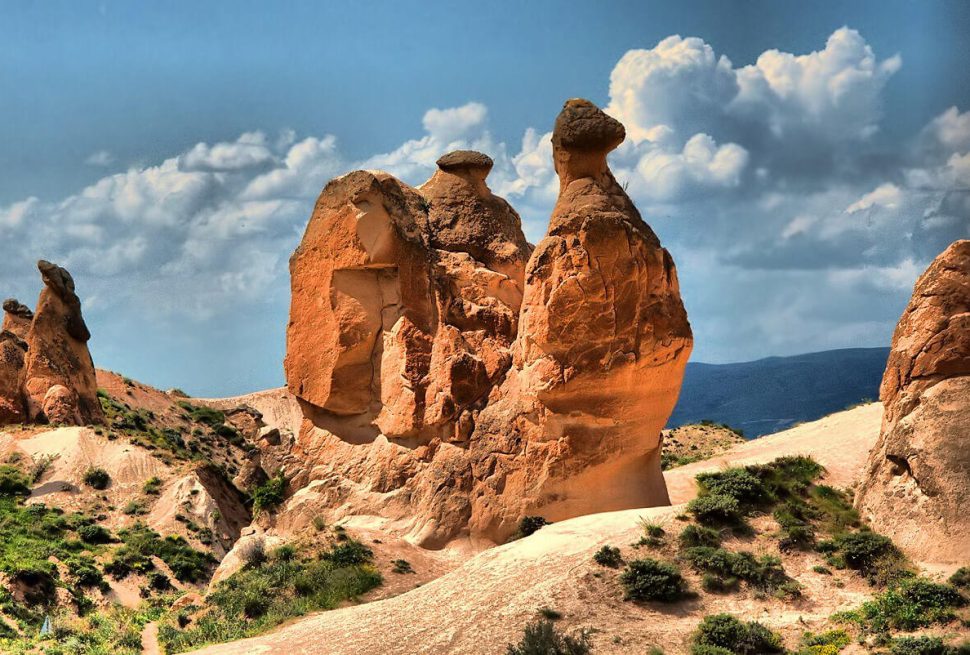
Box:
left=24, top=261, right=104, bottom=425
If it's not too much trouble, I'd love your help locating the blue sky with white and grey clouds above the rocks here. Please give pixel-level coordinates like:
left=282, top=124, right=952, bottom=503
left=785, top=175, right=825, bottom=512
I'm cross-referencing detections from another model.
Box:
left=0, top=0, right=970, bottom=395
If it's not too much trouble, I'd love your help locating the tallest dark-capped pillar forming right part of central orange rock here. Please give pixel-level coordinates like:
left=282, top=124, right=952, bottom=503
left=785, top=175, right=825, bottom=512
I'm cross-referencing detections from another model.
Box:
left=517, top=100, right=693, bottom=515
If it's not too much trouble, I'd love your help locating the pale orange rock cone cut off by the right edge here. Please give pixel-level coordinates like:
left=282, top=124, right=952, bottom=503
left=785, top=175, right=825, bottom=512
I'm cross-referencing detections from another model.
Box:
left=856, top=241, right=970, bottom=564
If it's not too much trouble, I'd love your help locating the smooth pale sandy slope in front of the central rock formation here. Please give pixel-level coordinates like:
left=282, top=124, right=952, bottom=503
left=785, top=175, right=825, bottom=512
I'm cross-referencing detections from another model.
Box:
left=187, top=404, right=882, bottom=655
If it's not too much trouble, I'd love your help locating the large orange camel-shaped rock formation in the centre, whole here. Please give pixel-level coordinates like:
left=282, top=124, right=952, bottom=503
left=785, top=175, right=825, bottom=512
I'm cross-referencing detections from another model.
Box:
left=278, top=100, right=692, bottom=547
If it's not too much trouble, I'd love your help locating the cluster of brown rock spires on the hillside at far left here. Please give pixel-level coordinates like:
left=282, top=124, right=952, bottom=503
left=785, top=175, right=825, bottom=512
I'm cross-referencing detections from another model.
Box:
left=0, top=261, right=104, bottom=425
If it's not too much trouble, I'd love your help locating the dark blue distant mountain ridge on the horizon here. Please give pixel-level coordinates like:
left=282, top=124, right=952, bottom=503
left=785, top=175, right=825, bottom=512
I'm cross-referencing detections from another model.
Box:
left=668, top=348, right=889, bottom=439
